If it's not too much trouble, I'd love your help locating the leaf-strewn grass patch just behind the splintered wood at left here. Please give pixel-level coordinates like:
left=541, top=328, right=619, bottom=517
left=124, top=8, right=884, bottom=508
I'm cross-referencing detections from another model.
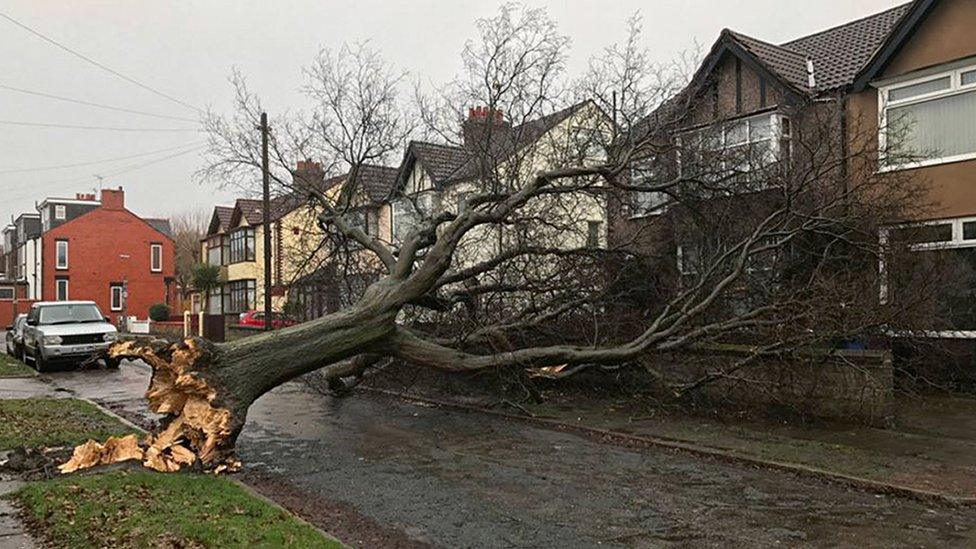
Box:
left=0, top=398, right=136, bottom=450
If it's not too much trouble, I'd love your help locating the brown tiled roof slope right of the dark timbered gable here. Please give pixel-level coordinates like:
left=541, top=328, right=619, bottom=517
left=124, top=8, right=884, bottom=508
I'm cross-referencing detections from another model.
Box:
left=781, top=3, right=912, bottom=90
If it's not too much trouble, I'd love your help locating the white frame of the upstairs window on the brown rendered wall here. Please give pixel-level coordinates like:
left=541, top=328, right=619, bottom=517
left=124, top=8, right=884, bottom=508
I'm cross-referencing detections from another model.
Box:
left=878, top=64, right=976, bottom=172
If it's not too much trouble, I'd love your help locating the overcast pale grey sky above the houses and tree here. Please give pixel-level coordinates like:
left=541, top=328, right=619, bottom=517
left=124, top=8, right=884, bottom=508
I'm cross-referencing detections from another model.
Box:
left=0, top=0, right=904, bottom=224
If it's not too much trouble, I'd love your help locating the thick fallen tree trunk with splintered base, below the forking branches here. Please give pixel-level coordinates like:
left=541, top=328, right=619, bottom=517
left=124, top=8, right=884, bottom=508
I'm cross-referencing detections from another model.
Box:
left=72, top=307, right=395, bottom=472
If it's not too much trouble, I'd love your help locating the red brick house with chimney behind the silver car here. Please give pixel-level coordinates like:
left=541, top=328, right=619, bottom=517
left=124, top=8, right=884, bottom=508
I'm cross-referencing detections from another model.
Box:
left=41, top=187, right=175, bottom=321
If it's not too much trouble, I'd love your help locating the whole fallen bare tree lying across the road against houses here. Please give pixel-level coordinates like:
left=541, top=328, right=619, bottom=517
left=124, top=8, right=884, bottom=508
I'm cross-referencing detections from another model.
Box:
left=63, top=6, right=944, bottom=470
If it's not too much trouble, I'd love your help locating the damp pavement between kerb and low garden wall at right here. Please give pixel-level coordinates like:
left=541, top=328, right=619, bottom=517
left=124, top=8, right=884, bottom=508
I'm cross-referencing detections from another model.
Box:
left=527, top=396, right=976, bottom=498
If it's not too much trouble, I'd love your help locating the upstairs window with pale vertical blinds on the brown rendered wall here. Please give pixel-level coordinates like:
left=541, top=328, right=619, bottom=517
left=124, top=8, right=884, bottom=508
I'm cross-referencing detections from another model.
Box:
left=878, top=62, right=976, bottom=170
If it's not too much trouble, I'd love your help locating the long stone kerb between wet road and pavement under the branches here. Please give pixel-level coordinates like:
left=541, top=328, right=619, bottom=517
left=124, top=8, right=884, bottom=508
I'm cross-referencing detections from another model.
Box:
left=361, top=387, right=976, bottom=507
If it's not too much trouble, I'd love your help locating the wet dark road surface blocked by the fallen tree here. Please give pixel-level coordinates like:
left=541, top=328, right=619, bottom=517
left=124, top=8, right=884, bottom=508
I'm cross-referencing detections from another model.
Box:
left=28, top=365, right=976, bottom=547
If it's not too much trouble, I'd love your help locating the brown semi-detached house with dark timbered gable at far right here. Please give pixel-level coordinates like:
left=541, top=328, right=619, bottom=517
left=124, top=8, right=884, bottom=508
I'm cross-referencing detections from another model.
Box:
left=611, top=0, right=976, bottom=339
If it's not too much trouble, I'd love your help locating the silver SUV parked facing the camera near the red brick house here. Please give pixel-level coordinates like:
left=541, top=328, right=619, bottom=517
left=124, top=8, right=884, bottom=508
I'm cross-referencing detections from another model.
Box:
left=21, top=301, right=119, bottom=372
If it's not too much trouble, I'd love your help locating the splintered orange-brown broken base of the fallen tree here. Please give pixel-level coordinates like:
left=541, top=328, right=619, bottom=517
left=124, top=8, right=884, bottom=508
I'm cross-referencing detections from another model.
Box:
left=60, top=339, right=243, bottom=473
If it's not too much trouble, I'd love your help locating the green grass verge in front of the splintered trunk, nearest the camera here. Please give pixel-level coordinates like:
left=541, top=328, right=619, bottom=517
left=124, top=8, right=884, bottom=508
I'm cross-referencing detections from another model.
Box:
left=13, top=471, right=343, bottom=548
